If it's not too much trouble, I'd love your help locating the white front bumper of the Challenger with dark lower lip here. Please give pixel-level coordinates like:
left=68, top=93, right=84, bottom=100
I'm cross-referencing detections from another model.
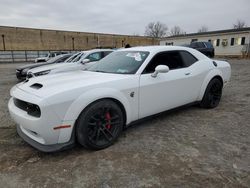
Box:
left=8, top=94, right=74, bottom=152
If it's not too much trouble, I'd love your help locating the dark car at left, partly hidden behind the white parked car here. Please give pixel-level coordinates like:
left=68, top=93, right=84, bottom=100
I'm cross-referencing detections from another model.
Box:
left=16, top=54, right=72, bottom=80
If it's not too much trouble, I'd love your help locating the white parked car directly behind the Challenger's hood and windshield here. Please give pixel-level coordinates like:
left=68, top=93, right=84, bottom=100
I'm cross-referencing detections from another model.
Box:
left=27, top=49, right=113, bottom=78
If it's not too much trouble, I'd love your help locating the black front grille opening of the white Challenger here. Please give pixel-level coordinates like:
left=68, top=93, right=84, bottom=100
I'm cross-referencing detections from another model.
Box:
left=13, top=98, right=41, bottom=117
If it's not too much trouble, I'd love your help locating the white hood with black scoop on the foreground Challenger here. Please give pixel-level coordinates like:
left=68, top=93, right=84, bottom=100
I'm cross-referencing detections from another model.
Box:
left=16, top=70, right=133, bottom=98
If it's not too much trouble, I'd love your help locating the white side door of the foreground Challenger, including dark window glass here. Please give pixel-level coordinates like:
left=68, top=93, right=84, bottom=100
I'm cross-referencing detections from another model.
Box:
left=139, top=51, right=201, bottom=118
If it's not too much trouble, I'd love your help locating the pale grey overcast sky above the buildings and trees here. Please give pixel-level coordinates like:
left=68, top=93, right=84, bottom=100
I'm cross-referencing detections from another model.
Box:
left=0, top=0, right=250, bottom=35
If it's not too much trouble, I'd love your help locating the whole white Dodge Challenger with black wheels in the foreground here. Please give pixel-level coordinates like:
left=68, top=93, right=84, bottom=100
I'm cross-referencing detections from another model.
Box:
left=8, top=46, right=231, bottom=152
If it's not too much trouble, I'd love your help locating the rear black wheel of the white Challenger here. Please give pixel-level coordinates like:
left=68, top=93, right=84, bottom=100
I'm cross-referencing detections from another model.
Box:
left=200, top=78, right=223, bottom=108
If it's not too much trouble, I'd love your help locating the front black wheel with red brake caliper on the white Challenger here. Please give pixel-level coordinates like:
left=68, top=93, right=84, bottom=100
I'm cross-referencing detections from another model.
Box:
left=76, top=99, right=124, bottom=150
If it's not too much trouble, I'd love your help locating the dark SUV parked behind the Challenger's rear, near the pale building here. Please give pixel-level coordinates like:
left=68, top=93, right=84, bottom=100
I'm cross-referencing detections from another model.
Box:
left=189, top=41, right=214, bottom=57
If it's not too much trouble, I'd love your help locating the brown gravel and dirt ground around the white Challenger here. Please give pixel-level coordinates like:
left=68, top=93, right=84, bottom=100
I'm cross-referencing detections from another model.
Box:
left=0, top=60, right=250, bottom=188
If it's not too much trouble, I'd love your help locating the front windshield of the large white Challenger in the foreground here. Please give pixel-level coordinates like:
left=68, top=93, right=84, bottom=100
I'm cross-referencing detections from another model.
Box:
left=87, top=51, right=149, bottom=74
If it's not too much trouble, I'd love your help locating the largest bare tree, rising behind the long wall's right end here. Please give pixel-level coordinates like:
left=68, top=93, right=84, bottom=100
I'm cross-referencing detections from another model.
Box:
left=145, top=22, right=168, bottom=38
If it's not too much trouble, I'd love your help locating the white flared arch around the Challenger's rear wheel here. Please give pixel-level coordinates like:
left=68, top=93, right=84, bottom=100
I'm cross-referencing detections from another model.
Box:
left=197, top=69, right=223, bottom=101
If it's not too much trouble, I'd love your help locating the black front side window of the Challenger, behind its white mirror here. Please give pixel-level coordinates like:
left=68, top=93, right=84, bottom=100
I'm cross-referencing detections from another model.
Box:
left=143, top=51, right=185, bottom=73
